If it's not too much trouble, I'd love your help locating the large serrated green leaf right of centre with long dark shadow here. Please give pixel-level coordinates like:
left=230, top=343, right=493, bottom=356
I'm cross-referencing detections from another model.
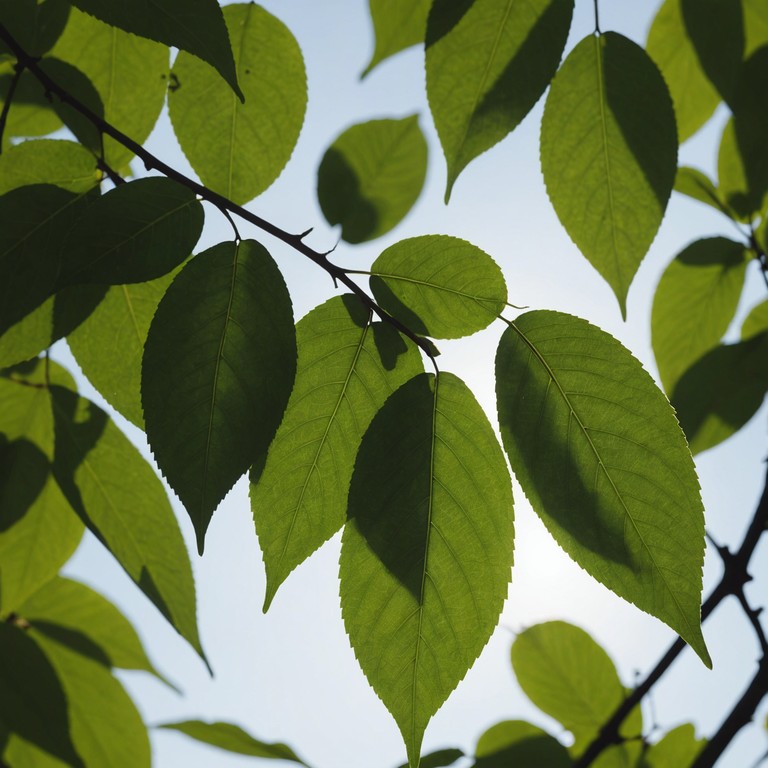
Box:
left=496, top=311, right=711, bottom=666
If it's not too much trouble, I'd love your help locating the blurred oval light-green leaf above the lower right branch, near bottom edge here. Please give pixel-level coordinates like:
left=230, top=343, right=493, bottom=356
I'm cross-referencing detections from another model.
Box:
left=512, top=621, right=643, bottom=756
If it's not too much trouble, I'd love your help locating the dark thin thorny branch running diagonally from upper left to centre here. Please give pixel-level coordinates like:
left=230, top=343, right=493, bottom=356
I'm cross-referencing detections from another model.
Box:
left=0, top=19, right=436, bottom=362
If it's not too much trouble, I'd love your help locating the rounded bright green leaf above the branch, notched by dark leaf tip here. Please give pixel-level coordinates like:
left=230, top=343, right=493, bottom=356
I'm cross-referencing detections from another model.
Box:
left=168, top=3, right=307, bottom=203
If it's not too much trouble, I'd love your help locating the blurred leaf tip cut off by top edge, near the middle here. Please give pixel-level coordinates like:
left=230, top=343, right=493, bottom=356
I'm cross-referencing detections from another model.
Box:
left=362, top=0, right=431, bottom=77
